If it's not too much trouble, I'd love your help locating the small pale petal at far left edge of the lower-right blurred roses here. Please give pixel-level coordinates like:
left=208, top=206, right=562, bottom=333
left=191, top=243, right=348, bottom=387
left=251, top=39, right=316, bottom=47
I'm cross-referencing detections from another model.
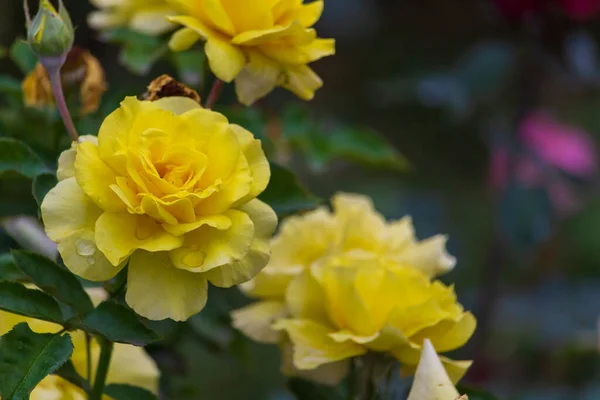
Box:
left=231, top=301, right=286, bottom=344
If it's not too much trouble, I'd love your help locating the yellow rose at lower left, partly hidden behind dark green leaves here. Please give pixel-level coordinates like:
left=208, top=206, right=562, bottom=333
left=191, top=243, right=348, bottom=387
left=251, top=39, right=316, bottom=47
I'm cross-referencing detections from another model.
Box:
left=0, top=289, right=160, bottom=400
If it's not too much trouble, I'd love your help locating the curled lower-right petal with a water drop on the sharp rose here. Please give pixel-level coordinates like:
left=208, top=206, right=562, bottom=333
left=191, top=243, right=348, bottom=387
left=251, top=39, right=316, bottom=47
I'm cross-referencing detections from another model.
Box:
left=169, top=210, right=254, bottom=272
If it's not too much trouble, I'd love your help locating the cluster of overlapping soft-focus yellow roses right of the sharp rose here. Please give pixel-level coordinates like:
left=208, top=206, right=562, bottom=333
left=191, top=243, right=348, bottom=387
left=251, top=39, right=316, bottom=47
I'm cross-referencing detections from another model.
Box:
left=233, top=194, right=476, bottom=383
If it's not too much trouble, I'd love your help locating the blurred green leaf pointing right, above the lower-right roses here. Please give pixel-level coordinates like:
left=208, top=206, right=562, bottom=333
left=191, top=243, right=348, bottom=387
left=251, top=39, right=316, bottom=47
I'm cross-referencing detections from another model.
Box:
left=329, top=128, right=409, bottom=171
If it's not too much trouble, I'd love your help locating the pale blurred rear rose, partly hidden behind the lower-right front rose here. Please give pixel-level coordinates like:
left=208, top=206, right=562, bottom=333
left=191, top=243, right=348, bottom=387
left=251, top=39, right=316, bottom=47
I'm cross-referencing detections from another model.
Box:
left=242, top=193, right=456, bottom=299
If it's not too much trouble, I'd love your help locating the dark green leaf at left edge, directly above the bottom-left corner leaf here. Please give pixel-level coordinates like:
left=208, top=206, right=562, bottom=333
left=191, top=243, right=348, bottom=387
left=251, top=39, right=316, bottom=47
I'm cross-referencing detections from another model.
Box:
left=0, top=282, right=63, bottom=324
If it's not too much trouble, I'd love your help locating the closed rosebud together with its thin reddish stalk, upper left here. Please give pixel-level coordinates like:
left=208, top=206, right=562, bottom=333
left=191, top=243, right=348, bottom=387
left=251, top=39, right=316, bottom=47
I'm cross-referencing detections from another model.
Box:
left=24, top=0, right=78, bottom=141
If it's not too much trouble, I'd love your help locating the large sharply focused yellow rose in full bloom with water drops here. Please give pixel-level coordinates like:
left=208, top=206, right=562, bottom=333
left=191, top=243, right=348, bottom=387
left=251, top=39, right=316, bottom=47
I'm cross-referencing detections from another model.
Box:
left=41, top=97, right=277, bottom=320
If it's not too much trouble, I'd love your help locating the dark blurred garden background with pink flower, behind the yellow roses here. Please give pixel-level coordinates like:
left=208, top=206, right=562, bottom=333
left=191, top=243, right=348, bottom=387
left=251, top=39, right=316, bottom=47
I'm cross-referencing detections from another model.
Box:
left=5, top=0, right=600, bottom=400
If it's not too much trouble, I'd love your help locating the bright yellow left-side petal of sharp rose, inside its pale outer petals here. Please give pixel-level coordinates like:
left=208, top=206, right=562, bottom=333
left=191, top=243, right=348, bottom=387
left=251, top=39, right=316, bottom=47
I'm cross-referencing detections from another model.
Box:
left=75, top=142, right=125, bottom=211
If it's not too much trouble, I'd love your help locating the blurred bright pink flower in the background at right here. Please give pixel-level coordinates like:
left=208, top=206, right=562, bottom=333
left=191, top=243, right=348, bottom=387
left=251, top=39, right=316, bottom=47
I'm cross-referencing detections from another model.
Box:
left=519, top=112, right=598, bottom=178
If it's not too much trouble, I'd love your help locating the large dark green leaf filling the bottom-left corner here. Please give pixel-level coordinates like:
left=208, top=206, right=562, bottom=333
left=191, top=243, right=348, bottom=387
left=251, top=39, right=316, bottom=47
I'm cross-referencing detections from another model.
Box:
left=0, top=323, right=73, bottom=400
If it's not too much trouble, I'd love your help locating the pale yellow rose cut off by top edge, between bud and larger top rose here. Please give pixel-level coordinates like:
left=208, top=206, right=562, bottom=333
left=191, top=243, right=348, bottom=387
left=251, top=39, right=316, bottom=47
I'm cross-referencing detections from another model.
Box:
left=88, top=0, right=174, bottom=35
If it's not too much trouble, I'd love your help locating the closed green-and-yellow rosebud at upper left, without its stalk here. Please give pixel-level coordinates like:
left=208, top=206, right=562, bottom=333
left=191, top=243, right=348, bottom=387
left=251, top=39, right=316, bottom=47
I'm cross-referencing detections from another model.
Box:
left=27, top=0, right=75, bottom=58
